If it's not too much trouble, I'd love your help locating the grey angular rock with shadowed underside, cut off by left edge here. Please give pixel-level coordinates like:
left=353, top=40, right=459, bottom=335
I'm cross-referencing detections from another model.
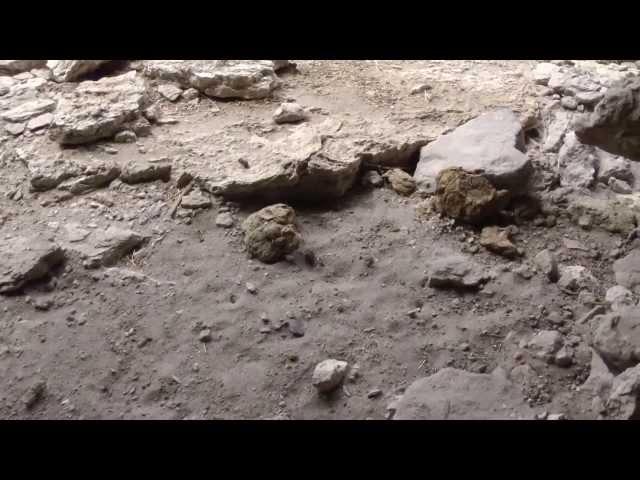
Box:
left=0, top=235, right=65, bottom=294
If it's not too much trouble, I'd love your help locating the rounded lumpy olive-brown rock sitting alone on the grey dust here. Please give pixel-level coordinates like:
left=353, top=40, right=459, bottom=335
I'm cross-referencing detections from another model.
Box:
left=242, top=203, right=301, bottom=263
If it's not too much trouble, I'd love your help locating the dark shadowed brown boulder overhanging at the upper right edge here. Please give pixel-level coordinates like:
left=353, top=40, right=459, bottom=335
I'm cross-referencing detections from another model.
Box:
left=574, top=77, right=640, bottom=161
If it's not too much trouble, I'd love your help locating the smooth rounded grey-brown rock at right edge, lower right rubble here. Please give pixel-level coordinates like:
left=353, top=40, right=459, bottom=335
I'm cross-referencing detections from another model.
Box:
left=593, top=307, right=640, bottom=371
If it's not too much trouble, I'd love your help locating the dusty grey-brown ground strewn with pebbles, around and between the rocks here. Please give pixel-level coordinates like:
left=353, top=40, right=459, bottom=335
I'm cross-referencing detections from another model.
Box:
left=0, top=61, right=632, bottom=419
